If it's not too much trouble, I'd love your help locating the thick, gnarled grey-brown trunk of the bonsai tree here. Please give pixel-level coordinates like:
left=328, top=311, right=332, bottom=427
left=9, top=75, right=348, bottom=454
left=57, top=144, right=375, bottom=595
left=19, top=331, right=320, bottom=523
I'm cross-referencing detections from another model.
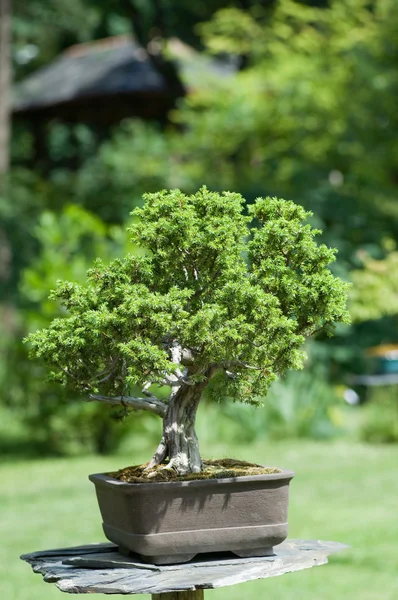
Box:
left=148, top=370, right=215, bottom=475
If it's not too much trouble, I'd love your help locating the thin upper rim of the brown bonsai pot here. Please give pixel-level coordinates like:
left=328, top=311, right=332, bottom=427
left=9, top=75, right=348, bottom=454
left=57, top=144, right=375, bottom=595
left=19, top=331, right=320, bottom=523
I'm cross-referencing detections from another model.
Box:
left=88, top=469, right=295, bottom=491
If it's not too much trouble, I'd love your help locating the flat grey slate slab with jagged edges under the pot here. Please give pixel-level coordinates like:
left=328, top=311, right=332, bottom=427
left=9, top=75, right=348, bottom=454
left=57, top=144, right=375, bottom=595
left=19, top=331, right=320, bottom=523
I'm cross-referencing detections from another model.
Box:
left=21, top=540, right=348, bottom=594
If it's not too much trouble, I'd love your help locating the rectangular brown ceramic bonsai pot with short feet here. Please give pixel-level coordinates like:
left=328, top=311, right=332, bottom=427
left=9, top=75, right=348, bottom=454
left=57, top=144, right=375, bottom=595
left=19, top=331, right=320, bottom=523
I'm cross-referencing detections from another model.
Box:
left=89, top=471, right=294, bottom=564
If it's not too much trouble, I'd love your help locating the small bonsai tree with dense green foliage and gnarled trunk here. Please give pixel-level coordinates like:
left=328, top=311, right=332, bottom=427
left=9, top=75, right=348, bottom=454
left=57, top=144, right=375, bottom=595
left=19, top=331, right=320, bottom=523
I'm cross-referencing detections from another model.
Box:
left=28, top=187, right=348, bottom=474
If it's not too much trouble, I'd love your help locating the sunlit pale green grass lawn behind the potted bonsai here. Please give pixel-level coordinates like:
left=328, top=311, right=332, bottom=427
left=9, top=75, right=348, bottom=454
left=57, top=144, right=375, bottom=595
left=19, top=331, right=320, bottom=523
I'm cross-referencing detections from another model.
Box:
left=0, top=441, right=398, bottom=600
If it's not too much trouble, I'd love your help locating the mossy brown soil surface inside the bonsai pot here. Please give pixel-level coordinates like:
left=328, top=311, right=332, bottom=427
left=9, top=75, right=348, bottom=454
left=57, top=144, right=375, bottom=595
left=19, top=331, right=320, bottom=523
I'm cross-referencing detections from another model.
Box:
left=107, top=458, right=281, bottom=483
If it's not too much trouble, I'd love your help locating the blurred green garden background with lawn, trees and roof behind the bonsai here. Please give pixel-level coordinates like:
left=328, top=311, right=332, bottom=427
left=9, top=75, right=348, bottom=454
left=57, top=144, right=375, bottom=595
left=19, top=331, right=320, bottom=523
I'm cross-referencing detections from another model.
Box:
left=0, top=0, right=398, bottom=600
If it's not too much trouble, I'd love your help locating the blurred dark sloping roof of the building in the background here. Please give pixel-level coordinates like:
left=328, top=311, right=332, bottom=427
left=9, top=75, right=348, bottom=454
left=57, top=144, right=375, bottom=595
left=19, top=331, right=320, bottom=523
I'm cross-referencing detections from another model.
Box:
left=13, top=36, right=234, bottom=125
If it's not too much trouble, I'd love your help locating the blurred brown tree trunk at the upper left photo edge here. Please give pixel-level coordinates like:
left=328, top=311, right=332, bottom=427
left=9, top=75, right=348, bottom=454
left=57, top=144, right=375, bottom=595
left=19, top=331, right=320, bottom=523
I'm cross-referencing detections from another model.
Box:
left=0, top=0, right=11, bottom=177
